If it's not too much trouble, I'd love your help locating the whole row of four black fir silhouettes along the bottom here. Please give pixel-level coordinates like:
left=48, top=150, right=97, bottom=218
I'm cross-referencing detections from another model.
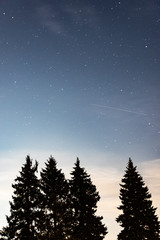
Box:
left=0, top=156, right=160, bottom=240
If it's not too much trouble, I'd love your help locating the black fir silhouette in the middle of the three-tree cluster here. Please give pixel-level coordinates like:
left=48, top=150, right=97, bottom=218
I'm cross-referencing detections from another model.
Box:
left=41, top=157, right=72, bottom=240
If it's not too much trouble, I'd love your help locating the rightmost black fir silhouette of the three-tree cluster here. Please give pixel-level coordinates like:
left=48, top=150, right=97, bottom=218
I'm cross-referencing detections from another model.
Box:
left=70, top=159, right=107, bottom=240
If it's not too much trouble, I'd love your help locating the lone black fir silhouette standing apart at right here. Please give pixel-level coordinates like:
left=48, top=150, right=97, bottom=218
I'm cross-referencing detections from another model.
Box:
left=116, top=159, right=160, bottom=240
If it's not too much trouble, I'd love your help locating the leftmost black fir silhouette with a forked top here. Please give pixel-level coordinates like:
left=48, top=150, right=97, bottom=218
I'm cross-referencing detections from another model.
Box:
left=2, top=156, right=41, bottom=240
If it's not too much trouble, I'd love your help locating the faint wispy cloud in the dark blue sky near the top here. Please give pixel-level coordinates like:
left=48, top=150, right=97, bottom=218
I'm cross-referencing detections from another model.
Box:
left=36, top=3, right=98, bottom=37
